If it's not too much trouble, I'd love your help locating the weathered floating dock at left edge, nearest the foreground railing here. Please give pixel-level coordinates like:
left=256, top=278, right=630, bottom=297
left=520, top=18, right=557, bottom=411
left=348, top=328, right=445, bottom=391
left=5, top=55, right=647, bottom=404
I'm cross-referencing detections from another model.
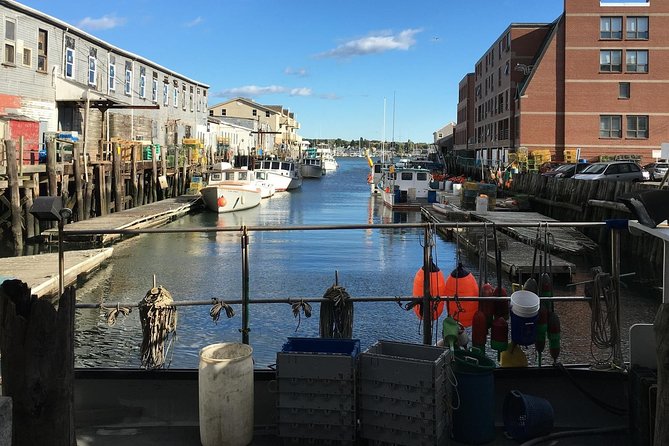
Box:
left=0, top=248, right=114, bottom=297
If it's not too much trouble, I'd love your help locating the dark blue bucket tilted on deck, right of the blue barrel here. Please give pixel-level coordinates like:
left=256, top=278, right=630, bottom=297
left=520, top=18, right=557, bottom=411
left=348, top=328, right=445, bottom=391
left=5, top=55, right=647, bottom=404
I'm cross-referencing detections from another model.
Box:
left=503, top=390, right=553, bottom=441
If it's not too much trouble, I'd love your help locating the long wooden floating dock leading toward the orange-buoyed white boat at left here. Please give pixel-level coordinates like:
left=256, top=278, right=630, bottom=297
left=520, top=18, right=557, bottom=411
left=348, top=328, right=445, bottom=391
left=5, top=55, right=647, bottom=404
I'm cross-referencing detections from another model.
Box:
left=42, top=195, right=200, bottom=246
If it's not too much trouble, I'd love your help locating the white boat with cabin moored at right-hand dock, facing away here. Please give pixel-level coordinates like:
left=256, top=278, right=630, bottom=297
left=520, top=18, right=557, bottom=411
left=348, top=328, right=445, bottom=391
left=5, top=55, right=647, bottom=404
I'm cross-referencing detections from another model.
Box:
left=382, top=167, right=437, bottom=208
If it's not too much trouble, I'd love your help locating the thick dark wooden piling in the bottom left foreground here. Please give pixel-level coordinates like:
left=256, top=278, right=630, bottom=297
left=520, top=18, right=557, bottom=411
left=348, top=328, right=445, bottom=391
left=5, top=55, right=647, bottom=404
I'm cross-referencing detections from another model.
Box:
left=0, top=280, right=76, bottom=446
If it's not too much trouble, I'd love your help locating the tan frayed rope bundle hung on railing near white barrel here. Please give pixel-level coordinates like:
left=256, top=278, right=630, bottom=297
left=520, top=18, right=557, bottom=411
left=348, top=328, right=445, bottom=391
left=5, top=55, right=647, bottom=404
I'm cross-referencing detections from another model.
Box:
left=139, top=286, right=177, bottom=369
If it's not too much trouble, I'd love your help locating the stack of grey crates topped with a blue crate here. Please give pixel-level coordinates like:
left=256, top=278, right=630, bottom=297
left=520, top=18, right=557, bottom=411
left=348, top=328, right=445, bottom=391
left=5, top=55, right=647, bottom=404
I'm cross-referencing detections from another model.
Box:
left=276, top=338, right=360, bottom=445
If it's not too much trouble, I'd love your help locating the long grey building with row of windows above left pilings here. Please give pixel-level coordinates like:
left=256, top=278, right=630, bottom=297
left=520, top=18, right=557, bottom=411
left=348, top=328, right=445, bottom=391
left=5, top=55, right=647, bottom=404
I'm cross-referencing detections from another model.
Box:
left=0, top=0, right=209, bottom=160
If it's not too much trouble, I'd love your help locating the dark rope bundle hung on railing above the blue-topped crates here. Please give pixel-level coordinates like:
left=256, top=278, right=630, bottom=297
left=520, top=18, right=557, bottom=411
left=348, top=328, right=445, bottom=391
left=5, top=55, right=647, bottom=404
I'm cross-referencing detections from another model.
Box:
left=319, top=284, right=353, bottom=339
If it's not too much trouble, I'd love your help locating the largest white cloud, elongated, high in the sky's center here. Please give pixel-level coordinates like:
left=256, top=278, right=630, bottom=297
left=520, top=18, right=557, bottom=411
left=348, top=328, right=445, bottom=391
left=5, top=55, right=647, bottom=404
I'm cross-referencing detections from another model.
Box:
left=318, top=29, right=422, bottom=59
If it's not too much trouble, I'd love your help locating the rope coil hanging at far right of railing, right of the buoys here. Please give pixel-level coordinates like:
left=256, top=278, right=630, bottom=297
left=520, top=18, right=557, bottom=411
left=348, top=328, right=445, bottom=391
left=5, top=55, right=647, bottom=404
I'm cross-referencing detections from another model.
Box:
left=590, top=268, right=622, bottom=366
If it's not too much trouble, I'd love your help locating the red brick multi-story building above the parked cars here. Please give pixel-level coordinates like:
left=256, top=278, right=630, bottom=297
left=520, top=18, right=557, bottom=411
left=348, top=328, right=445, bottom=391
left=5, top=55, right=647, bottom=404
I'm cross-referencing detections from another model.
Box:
left=455, top=0, right=669, bottom=165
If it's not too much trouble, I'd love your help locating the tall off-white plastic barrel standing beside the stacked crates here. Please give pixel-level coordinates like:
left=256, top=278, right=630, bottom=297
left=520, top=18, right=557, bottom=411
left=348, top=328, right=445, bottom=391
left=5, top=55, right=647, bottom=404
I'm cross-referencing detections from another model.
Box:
left=198, top=343, right=253, bottom=446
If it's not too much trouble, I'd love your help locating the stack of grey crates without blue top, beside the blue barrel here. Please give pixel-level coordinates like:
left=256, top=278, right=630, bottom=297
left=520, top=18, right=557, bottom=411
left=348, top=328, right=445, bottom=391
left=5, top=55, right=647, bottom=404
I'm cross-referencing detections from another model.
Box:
left=358, top=341, right=450, bottom=446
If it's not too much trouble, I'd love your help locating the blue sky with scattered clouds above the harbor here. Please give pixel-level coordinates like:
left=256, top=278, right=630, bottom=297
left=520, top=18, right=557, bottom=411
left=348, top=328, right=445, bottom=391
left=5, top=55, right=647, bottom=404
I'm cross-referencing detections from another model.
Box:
left=20, top=0, right=564, bottom=142
